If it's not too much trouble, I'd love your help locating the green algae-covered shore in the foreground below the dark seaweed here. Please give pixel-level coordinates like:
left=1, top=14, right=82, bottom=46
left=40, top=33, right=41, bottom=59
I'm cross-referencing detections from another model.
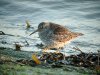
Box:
left=0, top=48, right=96, bottom=75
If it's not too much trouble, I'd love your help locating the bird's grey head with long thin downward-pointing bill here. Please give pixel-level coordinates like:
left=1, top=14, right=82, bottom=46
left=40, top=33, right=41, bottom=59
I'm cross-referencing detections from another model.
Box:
left=30, top=22, right=50, bottom=35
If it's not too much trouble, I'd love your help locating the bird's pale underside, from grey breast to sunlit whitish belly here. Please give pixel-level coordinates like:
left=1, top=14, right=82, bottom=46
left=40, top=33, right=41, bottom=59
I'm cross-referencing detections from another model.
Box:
left=39, top=31, right=69, bottom=48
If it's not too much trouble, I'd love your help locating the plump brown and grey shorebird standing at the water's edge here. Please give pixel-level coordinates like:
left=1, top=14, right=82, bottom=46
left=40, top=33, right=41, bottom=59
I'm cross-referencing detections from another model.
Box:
left=30, top=22, right=83, bottom=52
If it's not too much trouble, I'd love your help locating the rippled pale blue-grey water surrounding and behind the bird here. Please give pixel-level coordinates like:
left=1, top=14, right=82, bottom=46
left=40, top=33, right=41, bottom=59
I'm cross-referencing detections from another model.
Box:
left=0, top=0, right=100, bottom=52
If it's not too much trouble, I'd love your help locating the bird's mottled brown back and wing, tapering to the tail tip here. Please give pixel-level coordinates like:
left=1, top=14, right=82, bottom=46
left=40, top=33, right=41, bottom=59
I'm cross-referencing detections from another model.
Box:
left=50, top=23, right=82, bottom=42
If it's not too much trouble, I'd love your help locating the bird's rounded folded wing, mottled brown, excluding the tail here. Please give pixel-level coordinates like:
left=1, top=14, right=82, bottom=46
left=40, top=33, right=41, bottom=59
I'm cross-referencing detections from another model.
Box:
left=51, top=25, right=72, bottom=42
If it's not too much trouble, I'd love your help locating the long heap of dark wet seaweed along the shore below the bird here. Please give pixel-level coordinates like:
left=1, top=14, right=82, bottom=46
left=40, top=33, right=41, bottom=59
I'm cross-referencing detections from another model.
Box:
left=40, top=53, right=100, bottom=69
